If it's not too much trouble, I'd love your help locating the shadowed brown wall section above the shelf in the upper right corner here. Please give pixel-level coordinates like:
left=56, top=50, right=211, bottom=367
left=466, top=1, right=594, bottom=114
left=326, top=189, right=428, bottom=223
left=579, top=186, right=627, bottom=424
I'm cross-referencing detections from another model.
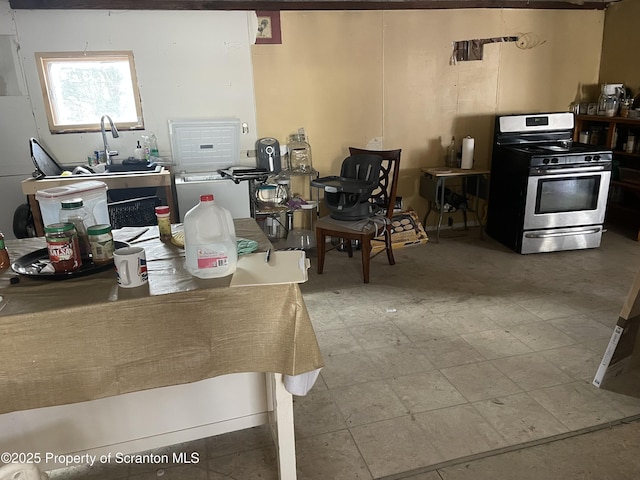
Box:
left=600, top=0, right=640, bottom=95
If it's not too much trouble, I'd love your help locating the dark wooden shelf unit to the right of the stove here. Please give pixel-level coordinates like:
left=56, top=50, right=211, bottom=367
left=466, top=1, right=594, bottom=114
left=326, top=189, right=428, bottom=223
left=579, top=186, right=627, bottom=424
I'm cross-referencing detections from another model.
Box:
left=573, top=115, right=640, bottom=241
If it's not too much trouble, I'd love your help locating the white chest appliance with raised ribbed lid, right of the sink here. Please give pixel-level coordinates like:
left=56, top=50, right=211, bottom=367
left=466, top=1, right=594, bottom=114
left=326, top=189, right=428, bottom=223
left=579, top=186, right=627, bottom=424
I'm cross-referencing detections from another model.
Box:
left=169, top=118, right=251, bottom=222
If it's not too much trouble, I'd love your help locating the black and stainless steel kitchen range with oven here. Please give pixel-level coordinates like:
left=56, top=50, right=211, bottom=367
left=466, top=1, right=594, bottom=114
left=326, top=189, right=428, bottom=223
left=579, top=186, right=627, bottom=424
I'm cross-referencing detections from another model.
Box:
left=487, top=112, right=612, bottom=254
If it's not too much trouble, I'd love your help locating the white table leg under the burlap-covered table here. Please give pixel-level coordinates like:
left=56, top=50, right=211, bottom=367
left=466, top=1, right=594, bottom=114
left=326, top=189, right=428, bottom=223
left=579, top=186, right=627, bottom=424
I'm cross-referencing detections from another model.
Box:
left=266, top=373, right=297, bottom=480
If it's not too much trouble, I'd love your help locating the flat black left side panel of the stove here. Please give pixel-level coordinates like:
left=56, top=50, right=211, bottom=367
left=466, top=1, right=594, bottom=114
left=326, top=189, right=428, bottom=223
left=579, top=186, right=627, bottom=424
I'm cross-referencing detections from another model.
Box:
left=487, top=146, right=529, bottom=252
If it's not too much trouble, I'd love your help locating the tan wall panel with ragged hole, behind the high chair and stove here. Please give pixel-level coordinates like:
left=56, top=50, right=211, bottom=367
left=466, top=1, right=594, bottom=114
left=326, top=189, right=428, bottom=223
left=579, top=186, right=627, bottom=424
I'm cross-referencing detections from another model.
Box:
left=252, top=9, right=604, bottom=221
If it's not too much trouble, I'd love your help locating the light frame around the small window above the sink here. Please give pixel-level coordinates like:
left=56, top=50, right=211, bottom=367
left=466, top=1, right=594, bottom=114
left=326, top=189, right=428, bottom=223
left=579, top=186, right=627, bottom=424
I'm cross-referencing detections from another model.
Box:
left=35, top=51, right=144, bottom=133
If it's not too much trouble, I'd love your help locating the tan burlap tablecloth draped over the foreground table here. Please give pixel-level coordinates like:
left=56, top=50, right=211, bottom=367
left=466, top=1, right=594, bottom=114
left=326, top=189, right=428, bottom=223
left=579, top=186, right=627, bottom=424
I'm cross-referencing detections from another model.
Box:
left=0, top=219, right=323, bottom=413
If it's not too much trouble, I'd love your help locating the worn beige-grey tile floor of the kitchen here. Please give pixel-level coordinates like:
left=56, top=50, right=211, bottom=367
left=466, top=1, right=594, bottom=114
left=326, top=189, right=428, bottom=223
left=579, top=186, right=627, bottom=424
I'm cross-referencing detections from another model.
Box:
left=51, top=225, right=640, bottom=480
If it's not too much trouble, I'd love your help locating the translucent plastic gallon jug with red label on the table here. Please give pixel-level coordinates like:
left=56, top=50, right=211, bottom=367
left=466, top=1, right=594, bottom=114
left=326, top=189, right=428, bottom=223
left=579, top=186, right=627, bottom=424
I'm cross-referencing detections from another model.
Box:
left=184, top=195, right=238, bottom=278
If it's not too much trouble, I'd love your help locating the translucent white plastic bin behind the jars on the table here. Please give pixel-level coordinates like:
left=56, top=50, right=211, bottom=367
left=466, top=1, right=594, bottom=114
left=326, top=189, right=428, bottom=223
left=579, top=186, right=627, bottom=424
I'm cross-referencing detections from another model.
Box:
left=36, top=180, right=110, bottom=231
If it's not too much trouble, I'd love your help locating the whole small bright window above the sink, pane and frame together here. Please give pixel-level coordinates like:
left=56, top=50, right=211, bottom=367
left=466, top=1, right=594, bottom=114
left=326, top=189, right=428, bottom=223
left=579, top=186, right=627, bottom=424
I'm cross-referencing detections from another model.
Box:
left=36, top=52, right=144, bottom=133
